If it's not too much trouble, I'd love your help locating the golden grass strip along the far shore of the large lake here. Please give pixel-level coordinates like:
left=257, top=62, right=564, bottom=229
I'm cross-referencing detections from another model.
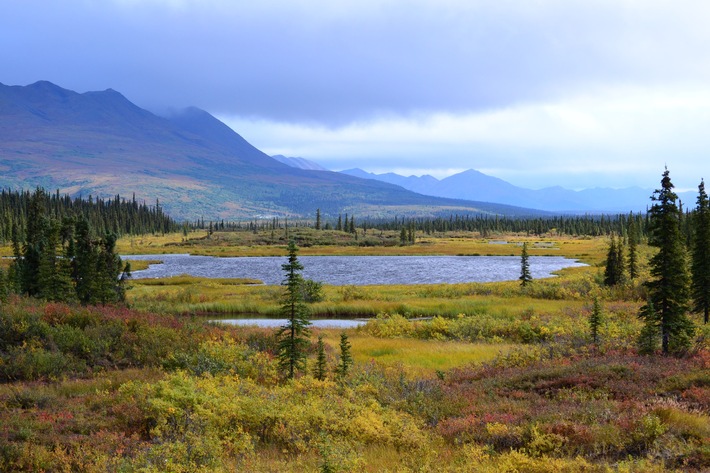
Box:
left=117, top=228, right=607, bottom=264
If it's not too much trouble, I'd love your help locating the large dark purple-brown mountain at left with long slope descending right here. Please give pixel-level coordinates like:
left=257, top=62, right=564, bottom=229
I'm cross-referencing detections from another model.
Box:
left=0, top=81, right=533, bottom=219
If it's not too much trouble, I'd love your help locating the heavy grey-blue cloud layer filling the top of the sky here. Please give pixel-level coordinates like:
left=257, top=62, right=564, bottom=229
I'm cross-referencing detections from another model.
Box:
left=5, top=0, right=710, bottom=123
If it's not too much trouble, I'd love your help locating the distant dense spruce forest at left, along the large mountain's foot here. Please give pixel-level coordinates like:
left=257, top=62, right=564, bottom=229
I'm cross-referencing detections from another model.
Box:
left=0, top=189, right=182, bottom=243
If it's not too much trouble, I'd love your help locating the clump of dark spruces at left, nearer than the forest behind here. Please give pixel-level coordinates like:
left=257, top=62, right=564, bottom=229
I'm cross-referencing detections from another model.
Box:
left=0, top=189, right=150, bottom=304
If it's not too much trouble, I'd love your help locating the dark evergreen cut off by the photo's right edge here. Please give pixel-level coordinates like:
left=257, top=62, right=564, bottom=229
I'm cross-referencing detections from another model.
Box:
left=691, top=180, right=710, bottom=324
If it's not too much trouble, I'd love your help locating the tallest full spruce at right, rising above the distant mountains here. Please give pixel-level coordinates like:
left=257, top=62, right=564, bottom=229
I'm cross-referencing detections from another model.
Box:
left=639, top=168, right=694, bottom=354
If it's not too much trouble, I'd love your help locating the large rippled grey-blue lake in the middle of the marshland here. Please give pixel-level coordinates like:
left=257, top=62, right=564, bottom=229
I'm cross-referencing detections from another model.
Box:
left=121, top=254, right=585, bottom=286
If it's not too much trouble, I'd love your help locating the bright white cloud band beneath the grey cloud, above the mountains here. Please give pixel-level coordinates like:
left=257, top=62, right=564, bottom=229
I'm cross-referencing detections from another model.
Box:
left=220, top=83, right=710, bottom=188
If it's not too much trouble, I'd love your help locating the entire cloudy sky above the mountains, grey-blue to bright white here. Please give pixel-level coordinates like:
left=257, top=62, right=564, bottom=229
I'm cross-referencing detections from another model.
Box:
left=0, top=0, right=710, bottom=190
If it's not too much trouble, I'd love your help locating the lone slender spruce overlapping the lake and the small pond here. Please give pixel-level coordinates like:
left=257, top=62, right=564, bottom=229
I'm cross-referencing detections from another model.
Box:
left=277, top=240, right=311, bottom=379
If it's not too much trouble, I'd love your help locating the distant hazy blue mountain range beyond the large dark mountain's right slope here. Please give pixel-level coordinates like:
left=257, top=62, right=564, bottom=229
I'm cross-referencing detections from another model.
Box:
left=341, top=169, right=695, bottom=213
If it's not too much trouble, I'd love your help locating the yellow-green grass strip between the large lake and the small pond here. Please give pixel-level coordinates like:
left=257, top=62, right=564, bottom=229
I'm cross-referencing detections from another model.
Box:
left=128, top=268, right=594, bottom=317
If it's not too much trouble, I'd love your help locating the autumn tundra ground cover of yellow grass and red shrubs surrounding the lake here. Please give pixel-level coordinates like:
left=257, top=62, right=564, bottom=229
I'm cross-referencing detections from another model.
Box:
left=0, top=179, right=710, bottom=472
